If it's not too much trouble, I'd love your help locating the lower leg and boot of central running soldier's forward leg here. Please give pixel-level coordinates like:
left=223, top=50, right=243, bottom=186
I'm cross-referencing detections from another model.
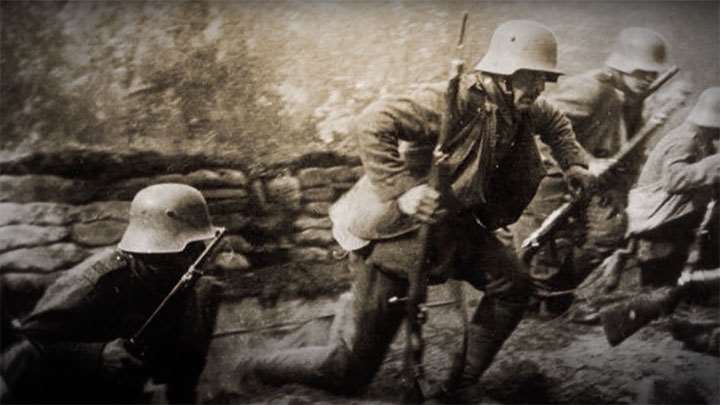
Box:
left=435, top=303, right=525, bottom=403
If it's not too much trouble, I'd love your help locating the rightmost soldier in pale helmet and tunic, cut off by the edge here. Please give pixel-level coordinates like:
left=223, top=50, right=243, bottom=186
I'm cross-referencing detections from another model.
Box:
left=627, top=87, right=720, bottom=286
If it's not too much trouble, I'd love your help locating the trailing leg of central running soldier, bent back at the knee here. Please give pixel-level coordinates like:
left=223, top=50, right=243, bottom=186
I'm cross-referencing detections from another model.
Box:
left=255, top=254, right=407, bottom=394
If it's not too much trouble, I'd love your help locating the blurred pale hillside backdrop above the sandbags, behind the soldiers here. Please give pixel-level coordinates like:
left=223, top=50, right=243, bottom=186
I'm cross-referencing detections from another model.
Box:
left=0, top=1, right=720, bottom=166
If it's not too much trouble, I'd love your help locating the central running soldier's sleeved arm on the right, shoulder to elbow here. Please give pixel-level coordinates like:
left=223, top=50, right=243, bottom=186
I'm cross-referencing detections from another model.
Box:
left=531, top=100, right=588, bottom=171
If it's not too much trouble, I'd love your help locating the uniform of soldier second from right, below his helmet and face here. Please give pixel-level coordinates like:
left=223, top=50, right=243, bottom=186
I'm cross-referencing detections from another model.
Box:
left=512, top=69, right=643, bottom=290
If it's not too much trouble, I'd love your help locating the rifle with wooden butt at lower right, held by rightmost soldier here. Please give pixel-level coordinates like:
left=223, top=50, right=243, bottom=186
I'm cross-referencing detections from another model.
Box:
left=600, top=200, right=720, bottom=346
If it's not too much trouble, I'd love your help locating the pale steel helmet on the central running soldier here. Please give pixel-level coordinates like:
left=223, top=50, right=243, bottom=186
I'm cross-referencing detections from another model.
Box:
left=475, top=20, right=563, bottom=76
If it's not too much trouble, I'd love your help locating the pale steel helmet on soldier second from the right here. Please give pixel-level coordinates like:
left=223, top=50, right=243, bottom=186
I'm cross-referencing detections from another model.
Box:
left=605, top=27, right=668, bottom=74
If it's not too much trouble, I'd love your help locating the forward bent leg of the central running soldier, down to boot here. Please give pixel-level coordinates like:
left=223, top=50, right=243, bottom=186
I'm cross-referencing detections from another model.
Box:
left=445, top=227, right=530, bottom=401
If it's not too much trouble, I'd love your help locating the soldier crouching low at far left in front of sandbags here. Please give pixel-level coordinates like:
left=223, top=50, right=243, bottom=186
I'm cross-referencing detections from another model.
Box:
left=0, top=184, right=218, bottom=403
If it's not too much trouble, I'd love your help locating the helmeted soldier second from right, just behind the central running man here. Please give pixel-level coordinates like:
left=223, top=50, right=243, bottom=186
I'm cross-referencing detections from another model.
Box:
left=512, top=28, right=668, bottom=312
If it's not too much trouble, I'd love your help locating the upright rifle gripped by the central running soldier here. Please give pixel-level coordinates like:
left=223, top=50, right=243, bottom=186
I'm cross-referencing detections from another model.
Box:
left=403, top=13, right=468, bottom=403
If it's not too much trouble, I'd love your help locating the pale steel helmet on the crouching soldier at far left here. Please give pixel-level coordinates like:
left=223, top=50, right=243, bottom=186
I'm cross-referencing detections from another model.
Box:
left=118, top=183, right=216, bottom=253
